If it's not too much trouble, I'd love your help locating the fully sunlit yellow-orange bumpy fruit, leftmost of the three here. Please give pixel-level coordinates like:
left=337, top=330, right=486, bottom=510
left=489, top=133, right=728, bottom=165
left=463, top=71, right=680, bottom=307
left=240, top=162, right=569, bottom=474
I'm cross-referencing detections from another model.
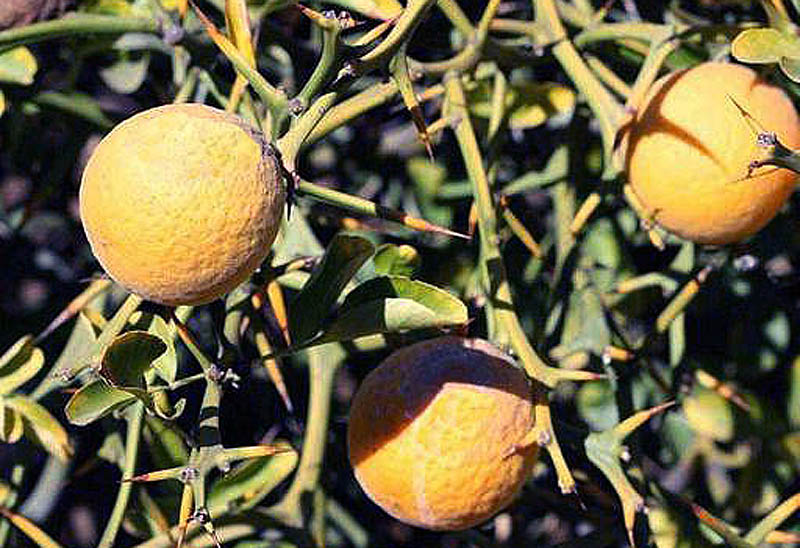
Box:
left=80, top=104, right=285, bottom=306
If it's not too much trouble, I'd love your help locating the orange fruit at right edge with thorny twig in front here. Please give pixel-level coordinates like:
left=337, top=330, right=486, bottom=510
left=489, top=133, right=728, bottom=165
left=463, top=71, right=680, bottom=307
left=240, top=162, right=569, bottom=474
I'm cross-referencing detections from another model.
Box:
left=626, top=63, right=800, bottom=245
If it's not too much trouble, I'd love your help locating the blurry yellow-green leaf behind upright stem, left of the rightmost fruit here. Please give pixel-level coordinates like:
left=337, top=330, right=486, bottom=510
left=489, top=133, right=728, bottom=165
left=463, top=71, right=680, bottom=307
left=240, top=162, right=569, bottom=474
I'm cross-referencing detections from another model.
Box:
left=467, top=80, right=576, bottom=129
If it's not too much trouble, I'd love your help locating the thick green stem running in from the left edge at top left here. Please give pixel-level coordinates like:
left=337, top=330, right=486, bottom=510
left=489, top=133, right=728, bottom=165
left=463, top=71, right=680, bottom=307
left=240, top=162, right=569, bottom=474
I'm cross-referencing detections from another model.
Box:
left=0, top=13, right=161, bottom=53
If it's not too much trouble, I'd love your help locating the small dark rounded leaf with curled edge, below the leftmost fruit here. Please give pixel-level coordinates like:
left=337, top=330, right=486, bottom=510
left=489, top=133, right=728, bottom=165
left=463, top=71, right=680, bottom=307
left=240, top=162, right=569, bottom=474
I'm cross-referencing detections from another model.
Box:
left=100, top=331, right=167, bottom=389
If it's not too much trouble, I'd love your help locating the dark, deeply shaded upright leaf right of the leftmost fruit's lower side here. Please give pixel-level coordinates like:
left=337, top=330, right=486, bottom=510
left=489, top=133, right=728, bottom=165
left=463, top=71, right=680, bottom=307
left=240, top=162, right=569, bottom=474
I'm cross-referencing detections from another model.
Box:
left=289, top=234, right=375, bottom=343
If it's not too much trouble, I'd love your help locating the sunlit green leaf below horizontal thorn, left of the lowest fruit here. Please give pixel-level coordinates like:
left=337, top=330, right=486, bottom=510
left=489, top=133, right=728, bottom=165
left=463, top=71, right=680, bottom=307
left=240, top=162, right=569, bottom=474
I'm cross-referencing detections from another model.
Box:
left=208, top=451, right=299, bottom=515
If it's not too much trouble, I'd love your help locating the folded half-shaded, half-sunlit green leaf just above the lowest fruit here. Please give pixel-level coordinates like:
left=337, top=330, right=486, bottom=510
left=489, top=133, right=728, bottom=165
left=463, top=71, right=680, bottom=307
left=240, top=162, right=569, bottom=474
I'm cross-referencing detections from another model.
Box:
left=315, top=276, right=469, bottom=343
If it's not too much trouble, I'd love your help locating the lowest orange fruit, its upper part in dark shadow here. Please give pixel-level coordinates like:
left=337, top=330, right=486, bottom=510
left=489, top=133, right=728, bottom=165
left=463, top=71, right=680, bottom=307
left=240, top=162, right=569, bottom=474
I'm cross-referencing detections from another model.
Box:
left=348, top=337, right=537, bottom=530
